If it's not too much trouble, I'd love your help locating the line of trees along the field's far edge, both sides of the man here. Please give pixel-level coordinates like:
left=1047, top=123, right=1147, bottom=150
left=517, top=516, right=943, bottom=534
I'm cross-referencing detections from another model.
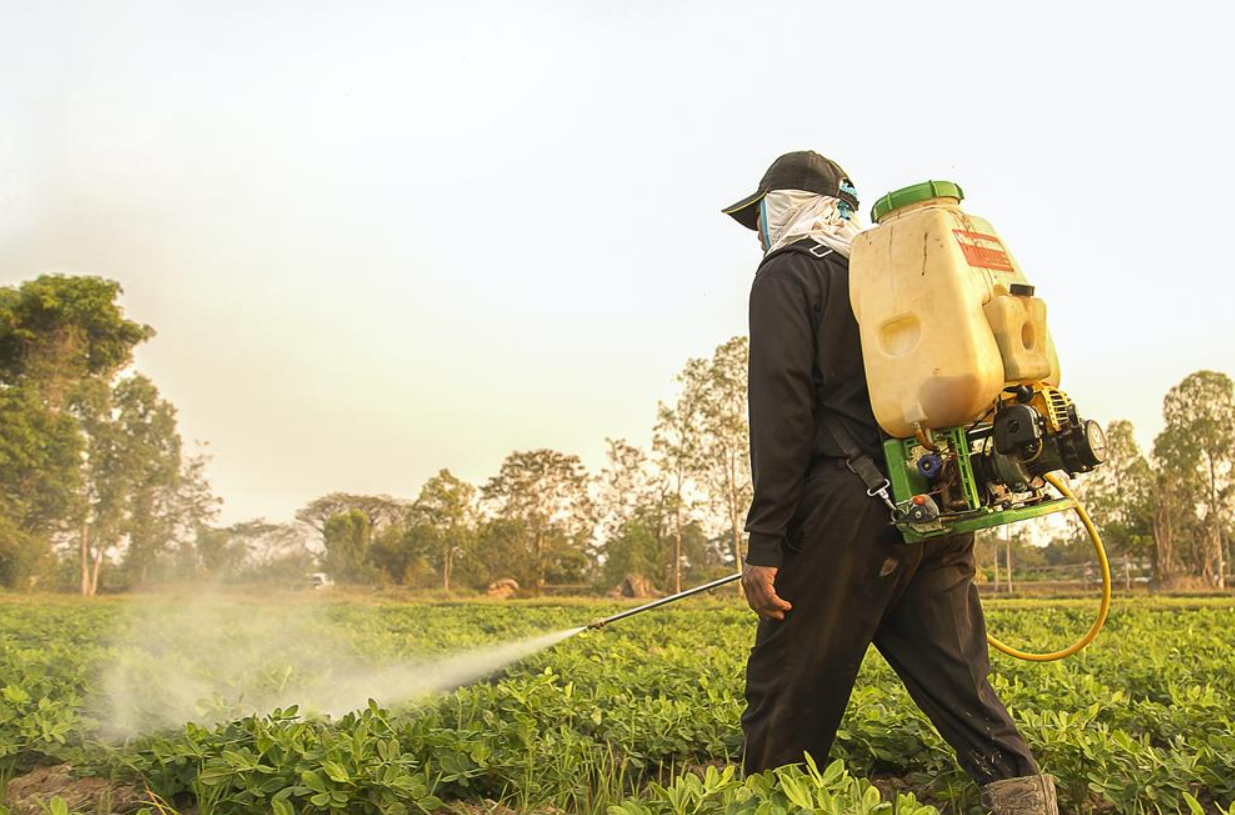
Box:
left=0, top=275, right=1235, bottom=594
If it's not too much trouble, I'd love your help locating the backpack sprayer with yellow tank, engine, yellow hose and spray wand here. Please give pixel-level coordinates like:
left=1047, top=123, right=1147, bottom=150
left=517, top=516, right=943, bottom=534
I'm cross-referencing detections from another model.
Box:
left=588, top=182, right=1110, bottom=662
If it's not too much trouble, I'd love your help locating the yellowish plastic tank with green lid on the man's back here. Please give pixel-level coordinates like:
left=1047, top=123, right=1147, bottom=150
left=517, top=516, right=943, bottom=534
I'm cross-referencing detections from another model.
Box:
left=850, top=182, right=1060, bottom=438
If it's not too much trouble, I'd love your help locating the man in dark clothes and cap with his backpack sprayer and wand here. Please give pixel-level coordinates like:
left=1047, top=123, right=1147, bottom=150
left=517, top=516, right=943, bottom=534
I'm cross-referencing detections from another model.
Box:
left=593, top=152, right=1110, bottom=815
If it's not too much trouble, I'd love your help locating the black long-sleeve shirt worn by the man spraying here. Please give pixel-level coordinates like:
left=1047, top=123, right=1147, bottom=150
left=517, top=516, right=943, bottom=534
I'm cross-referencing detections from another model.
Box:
left=746, top=238, right=883, bottom=566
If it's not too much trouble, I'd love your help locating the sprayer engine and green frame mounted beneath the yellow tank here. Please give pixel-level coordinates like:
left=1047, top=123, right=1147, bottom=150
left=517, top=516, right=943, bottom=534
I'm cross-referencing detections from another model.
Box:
left=884, top=384, right=1107, bottom=542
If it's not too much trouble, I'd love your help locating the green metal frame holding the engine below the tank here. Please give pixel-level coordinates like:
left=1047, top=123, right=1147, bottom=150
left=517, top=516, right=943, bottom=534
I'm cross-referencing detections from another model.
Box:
left=883, top=427, right=1076, bottom=543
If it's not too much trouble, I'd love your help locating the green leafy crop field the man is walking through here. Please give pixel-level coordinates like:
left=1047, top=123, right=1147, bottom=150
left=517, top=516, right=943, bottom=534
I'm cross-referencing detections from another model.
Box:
left=0, top=596, right=1235, bottom=815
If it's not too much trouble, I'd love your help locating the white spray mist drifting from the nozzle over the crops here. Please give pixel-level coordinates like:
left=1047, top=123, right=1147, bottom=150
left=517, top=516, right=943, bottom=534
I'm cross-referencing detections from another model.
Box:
left=90, top=595, right=582, bottom=738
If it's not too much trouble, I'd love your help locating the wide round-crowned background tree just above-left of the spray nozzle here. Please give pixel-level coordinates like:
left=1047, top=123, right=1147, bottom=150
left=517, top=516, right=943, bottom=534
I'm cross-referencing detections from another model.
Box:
left=482, top=449, right=595, bottom=590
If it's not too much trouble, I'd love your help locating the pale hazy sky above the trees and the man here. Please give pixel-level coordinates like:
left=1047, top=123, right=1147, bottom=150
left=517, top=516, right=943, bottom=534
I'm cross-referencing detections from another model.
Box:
left=0, top=0, right=1235, bottom=521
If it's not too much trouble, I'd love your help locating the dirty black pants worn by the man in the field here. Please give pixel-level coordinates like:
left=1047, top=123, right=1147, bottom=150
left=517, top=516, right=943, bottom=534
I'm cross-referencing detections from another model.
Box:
left=742, top=461, right=1039, bottom=784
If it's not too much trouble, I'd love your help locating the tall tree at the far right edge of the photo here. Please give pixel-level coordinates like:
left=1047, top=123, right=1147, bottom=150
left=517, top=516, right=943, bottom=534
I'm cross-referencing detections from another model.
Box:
left=1153, top=370, right=1235, bottom=589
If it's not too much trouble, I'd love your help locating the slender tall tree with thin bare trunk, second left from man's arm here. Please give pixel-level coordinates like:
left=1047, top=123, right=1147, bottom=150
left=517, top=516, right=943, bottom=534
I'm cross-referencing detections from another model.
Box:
left=652, top=358, right=708, bottom=593
